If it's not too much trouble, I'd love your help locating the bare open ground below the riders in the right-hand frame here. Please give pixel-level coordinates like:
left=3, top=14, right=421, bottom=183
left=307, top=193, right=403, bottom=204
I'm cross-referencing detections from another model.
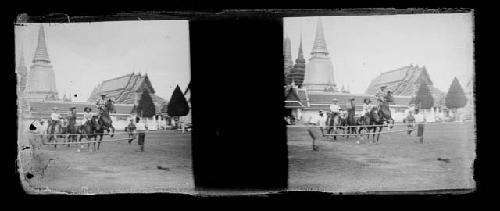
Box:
left=288, top=123, right=476, bottom=193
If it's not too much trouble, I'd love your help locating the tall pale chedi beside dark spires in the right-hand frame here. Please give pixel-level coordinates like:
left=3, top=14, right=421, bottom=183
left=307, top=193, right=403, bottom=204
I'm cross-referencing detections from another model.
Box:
left=302, top=18, right=336, bottom=91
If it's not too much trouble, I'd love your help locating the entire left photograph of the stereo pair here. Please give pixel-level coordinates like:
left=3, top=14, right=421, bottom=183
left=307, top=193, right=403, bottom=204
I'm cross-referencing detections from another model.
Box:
left=14, top=20, right=194, bottom=194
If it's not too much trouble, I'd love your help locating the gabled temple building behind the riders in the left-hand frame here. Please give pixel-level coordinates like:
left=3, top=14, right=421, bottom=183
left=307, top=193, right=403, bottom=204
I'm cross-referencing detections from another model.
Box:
left=87, top=73, right=166, bottom=106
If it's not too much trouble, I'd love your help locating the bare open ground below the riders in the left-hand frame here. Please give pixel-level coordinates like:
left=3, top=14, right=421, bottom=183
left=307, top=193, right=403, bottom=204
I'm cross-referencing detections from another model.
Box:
left=19, top=131, right=194, bottom=194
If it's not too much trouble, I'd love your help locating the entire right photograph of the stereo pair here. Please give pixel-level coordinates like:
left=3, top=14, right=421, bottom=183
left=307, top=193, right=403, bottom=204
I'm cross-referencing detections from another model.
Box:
left=283, top=11, right=476, bottom=193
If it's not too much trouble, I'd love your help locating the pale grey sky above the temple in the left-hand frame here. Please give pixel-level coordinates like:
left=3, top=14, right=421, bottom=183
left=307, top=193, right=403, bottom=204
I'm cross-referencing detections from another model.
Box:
left=15, top=20, right=191, bottom=102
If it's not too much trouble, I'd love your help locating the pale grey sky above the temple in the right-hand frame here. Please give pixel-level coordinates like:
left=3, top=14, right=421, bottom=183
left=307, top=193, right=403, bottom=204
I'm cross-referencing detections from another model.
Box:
left=284, top=13, right=474, bottom=93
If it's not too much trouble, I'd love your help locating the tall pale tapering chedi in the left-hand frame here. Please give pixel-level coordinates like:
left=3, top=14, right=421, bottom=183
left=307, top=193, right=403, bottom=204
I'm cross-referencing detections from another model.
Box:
left=27, top=25, right=59, bottom=100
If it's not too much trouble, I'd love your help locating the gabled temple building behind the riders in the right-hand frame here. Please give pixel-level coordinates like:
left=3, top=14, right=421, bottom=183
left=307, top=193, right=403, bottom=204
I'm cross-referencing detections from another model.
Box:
left=366, top=65, right=445, bottom=104
